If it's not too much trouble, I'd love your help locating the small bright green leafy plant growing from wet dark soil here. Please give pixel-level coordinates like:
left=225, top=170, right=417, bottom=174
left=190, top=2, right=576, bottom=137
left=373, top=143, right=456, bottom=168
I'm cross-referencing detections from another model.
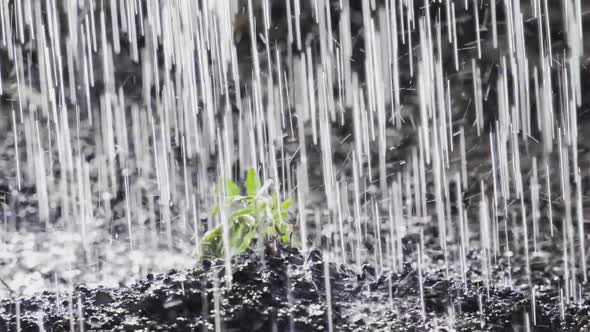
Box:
left=200, top=168, right=293, bottom=258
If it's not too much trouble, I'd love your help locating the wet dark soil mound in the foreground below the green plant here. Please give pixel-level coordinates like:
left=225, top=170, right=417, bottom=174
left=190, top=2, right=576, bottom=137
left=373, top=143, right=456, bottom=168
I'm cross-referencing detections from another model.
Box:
left=0, top=241, right=590, bottom=331
